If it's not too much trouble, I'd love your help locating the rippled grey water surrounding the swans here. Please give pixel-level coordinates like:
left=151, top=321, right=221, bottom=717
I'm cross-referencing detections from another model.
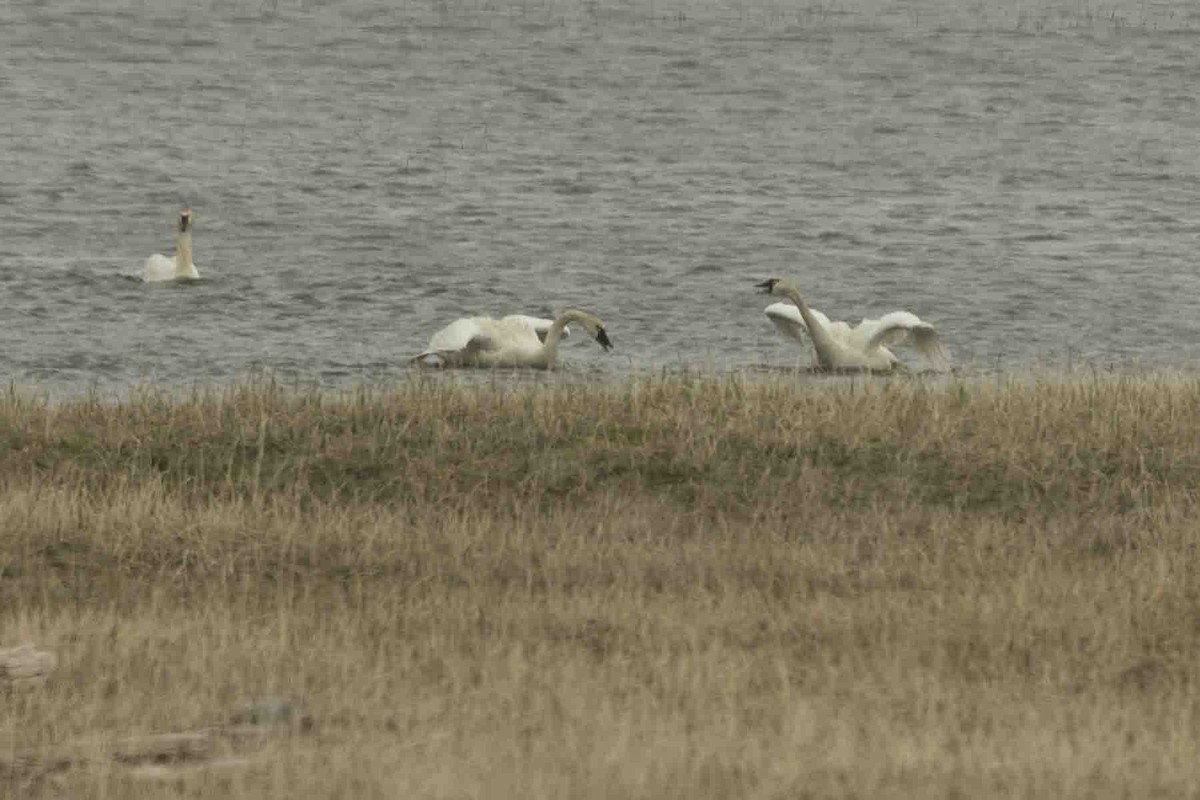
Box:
left=0, top=0, right=1200, bottom=391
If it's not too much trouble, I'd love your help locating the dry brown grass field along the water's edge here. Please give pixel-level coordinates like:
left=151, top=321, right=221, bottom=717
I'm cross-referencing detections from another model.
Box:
left=0, top=377, right=1200, bottom=800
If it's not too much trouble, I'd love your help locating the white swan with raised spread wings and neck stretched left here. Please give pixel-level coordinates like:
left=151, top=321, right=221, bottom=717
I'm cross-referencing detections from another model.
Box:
left=757, top=278, right=950, bottom=371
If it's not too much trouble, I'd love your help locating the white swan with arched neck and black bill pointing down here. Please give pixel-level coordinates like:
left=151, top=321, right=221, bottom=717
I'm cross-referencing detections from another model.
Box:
left=410, top=308, right=612, bottom=369
